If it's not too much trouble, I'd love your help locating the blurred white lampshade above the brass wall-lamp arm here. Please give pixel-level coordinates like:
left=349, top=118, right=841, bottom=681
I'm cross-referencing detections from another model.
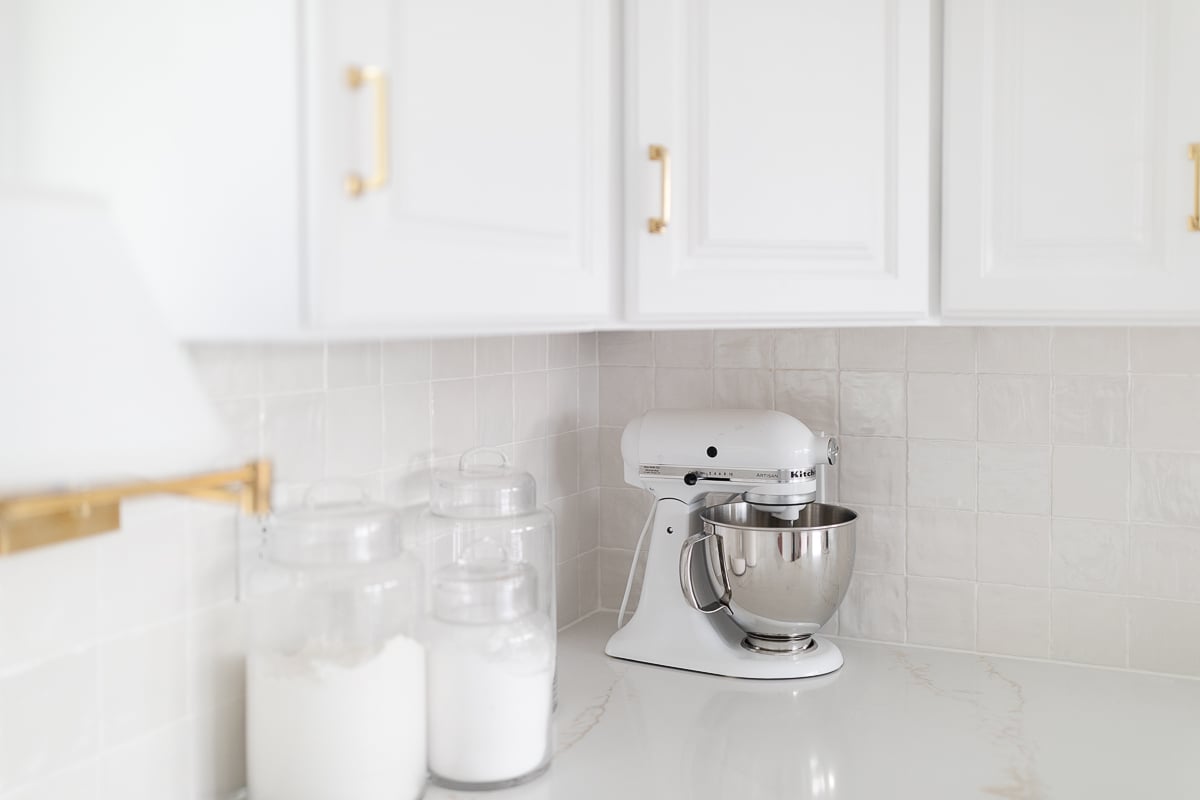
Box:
left=0, top=191, right=228, bottom=497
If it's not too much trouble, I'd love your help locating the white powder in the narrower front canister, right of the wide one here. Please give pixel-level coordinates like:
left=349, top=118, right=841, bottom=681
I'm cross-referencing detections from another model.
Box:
left=428, top=613, right=554, bottom=784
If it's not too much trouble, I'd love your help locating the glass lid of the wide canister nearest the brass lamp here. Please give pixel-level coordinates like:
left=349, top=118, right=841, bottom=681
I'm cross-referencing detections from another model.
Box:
left=265, top=485, right=403, bottom=566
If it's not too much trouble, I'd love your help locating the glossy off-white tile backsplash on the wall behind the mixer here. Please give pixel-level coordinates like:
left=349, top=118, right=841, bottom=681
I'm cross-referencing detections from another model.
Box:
left=599, top=327, right=1200, bottom=675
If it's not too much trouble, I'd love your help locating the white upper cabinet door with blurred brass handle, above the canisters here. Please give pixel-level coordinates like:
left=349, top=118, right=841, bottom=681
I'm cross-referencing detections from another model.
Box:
left=306, top=0, right=617, bottom=332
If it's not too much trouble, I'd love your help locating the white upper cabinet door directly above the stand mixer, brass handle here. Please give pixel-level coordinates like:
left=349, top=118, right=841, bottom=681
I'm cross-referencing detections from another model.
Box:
left=625, top=0, right=934, bottom=323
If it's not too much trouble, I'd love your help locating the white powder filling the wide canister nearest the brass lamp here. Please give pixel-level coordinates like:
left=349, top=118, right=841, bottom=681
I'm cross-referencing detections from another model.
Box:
left=246, top=636, right=426, bottom=800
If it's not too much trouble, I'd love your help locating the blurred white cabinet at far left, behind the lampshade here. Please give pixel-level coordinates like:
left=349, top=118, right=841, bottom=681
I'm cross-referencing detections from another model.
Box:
left=0, top=0, right=301, bottom=338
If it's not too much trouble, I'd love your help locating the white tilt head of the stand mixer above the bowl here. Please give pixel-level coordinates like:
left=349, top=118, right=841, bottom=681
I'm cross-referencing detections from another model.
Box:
left=620, top=409, right=838, bottom=519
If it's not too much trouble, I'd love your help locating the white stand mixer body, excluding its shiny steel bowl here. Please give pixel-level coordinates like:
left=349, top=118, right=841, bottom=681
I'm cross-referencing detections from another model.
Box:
left=605, top=410, right=854, bottom=679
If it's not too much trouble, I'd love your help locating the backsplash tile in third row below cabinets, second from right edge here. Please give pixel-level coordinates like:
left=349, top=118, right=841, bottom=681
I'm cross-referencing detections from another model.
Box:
left=1051, top=447, right=1129, bottom=521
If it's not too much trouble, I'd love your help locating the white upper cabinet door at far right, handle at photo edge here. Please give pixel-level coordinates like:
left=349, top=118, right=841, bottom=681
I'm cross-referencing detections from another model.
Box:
left=942, top=0, right=1200, bottom=320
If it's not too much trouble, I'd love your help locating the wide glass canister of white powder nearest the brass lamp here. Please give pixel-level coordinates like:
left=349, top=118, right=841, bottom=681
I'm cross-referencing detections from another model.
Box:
left=246, top=497, right=427, bottom=800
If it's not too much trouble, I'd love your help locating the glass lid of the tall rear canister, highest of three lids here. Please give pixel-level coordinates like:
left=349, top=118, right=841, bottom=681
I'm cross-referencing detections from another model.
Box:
left=430, top=447, right=538, bottom=519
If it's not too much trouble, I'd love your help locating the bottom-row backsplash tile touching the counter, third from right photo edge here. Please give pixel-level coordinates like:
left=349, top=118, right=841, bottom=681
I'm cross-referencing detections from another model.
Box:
left=976, top=583, right=1050, bottom=658
